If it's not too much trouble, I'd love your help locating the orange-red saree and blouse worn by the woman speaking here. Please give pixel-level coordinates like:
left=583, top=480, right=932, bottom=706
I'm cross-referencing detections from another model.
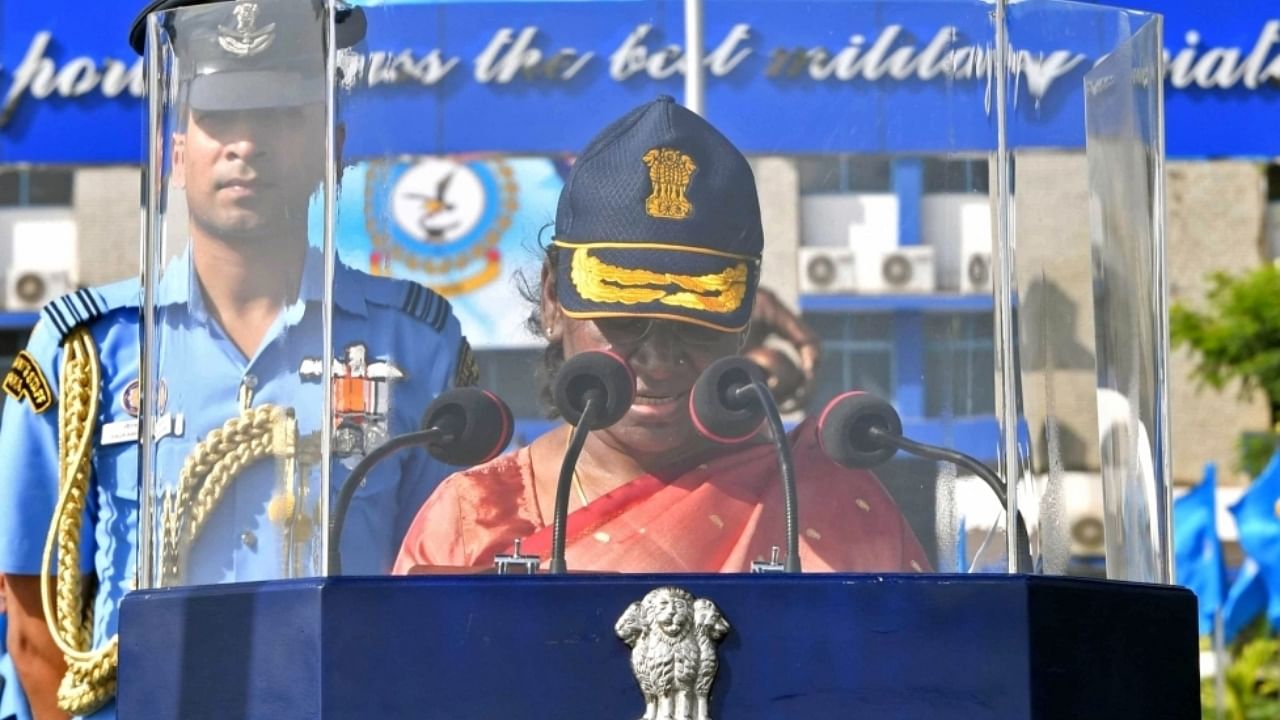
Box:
left=394, top=421, right=928, bottom=574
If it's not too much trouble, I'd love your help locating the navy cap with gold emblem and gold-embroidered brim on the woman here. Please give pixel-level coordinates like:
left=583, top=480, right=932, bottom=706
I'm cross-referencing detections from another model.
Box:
left=554, top=96, right=764, bottom=332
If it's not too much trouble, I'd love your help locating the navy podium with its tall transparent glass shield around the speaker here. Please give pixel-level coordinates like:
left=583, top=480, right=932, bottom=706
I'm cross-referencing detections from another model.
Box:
left=120, top=0, right=1198, bottom=719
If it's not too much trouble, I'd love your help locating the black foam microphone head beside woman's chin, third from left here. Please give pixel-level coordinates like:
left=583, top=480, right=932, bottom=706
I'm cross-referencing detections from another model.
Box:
left=689, top=356, right=764, bottom=443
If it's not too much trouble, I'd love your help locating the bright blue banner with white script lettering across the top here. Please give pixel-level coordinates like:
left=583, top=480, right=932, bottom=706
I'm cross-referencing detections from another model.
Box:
left=0, top=0, right=1280, bottom=164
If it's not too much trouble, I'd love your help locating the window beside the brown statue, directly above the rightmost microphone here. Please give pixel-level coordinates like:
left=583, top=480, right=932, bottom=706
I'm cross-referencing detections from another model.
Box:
left=804, top=313, right=893, bottom=414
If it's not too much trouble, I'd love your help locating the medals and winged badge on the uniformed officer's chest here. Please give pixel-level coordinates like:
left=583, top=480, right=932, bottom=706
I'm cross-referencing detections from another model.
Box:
left=298, top=342, right=404, bottom=457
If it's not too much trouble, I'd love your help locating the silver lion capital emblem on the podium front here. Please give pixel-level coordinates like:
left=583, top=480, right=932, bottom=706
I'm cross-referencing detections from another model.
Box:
left=613, top=587, right=730, bottom=720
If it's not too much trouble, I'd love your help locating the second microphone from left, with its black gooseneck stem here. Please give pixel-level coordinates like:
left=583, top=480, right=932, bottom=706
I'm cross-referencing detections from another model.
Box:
left=548, top=350, right=636, bottom=574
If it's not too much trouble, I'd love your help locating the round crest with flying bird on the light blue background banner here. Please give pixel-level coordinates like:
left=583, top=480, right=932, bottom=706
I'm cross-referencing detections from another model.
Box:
left=365, top=158, right=520, bottom=297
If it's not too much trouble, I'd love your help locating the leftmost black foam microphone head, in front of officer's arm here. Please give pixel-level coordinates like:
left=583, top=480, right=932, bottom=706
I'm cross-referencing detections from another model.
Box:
left=422, top=387, right=513, bottom=466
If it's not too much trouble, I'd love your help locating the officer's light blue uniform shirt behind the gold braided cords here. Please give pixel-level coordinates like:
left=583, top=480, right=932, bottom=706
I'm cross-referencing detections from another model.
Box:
left=0, top=251, right=468, bottom=717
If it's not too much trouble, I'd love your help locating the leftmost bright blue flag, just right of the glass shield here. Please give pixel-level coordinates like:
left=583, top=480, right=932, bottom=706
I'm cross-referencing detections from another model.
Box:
left=1174, top=462, right=1226, bottom=635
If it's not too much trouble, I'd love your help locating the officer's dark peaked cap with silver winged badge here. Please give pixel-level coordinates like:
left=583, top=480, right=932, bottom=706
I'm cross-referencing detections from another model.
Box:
left=129, top=0, right=365, bottom=110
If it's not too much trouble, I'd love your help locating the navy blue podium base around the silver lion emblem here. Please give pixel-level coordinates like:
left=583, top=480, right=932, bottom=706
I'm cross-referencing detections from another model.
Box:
left=119, top=575, right=1199, bottom=720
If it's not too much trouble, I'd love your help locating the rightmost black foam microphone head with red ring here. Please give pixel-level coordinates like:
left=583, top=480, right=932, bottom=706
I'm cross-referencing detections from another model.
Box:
left=818, top=391, right=902, bottom=469
